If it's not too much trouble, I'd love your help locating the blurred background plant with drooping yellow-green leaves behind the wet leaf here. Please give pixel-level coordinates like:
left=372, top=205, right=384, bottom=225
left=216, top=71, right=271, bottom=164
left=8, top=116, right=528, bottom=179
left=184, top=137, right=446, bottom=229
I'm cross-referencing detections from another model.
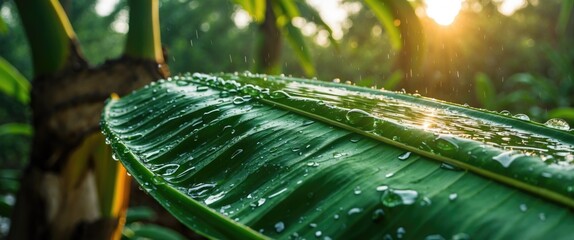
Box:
left=235, top=0, right=424, bottom=78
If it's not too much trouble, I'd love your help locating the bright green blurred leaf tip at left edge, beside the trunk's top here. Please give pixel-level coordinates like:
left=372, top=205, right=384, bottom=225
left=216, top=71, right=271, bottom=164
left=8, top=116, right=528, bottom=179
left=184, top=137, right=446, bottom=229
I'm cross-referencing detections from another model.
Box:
left=0, top=57, right=30, bottom=104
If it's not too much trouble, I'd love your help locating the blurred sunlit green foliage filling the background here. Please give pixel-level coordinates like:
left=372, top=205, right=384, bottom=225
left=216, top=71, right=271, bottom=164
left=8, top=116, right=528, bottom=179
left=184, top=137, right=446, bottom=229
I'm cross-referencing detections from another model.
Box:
left=0, top=0, right=574, bottom=235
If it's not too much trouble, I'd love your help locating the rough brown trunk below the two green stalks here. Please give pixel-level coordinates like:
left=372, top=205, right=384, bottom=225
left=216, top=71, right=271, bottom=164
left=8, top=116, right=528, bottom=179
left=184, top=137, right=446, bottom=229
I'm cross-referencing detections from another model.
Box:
left=8, top=54, right=168, bottom=239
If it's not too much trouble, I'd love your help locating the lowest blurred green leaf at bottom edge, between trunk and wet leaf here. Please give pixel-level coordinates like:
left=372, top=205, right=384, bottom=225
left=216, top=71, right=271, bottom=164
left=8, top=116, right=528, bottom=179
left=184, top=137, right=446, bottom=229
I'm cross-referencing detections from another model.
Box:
left=123, top=223, right=187, bottom=240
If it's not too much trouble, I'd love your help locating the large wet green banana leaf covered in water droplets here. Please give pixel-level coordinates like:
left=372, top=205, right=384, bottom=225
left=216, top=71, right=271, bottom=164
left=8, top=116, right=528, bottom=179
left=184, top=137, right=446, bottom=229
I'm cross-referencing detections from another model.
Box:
left=102, top=73, right=574, bottom=239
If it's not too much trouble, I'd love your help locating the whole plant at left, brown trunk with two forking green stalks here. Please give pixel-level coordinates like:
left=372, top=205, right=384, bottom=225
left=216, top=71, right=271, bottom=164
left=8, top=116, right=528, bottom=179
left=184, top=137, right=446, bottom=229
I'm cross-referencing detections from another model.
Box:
left=9, top=0, right=168, bottom=239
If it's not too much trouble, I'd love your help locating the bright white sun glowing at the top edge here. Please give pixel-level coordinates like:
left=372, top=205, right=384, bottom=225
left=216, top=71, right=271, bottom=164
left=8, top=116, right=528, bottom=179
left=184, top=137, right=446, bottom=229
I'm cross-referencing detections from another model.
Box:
left=425, top=0, right=462, bottom=26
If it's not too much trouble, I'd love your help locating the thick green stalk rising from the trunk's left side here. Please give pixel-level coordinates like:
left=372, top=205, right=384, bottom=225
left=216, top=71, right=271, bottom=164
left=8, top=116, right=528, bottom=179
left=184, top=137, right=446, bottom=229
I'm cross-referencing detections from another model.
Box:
left=15, top=0, right=76, bottom=76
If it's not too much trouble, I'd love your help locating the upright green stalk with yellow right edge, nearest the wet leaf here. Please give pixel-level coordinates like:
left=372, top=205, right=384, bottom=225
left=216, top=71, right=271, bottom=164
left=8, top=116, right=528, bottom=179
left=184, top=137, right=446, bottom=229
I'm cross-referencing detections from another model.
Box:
left=125, top=0, right=164, bottom=63
